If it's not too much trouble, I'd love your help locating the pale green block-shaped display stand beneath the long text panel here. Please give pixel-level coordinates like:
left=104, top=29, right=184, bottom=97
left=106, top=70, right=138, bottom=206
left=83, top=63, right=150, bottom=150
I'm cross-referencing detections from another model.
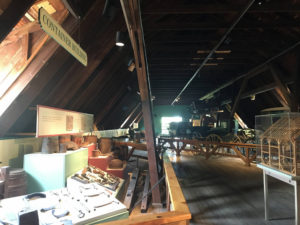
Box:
left=24, top=148, right=88, bottom=193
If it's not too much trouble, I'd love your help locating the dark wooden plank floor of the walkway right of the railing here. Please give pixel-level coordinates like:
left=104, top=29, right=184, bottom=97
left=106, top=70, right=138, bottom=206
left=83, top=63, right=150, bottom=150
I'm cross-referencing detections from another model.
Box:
left=170, top=152, right=294, bottom=225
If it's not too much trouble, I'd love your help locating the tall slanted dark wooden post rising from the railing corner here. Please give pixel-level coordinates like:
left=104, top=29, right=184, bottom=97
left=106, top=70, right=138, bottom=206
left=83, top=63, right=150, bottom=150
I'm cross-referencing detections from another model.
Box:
left=121, top=0, right=161, bottom=205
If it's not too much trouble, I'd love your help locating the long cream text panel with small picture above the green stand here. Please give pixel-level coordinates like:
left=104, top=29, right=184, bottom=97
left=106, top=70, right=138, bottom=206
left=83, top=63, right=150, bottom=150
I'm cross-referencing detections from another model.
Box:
left=36, top=105, right=94, bottom=137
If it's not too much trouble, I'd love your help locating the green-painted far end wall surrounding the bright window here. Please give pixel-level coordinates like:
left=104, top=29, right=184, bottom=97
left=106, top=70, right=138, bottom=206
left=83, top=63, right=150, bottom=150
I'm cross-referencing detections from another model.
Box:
left=139, top=105, right=192, bottom=135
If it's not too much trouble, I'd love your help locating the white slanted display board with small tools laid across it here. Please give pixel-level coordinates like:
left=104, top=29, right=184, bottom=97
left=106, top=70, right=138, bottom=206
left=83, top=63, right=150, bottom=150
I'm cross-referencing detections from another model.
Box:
left=0, top=186, right=129, bottom=225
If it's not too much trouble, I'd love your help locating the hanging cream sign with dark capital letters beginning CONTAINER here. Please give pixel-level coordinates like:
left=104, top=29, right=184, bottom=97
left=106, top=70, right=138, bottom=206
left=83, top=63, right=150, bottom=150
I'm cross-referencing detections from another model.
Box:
left=39, top=8, right=88, bottom=66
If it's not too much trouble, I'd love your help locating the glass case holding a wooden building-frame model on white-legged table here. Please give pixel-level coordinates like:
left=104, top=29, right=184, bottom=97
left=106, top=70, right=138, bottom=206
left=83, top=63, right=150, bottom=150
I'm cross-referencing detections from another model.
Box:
left=255, top=113, right=300, bottom=176
